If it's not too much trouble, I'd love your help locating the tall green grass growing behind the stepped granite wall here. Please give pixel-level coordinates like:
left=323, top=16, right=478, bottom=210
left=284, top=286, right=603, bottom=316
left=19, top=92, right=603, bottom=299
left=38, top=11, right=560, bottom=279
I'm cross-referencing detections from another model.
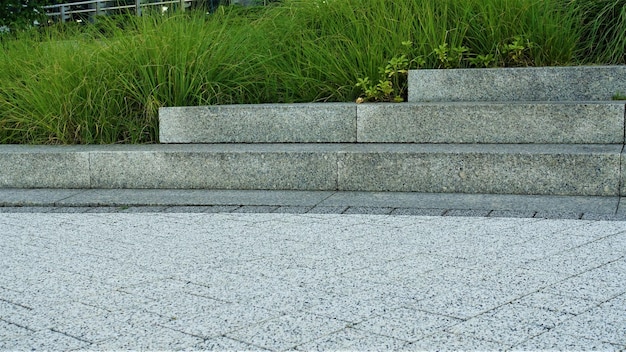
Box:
left=0, top=0, right=626, bottom=144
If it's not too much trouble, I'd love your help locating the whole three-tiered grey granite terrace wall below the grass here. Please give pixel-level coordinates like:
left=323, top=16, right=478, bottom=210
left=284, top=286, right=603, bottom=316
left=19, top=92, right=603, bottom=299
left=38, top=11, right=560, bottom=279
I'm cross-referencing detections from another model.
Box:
left=0, top=66, right=626, bottom=196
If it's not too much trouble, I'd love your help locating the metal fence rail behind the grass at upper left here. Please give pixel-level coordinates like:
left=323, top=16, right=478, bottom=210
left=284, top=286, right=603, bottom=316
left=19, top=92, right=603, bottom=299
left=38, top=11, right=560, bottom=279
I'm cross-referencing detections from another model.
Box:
left=44, top=0, right=249, bottom=22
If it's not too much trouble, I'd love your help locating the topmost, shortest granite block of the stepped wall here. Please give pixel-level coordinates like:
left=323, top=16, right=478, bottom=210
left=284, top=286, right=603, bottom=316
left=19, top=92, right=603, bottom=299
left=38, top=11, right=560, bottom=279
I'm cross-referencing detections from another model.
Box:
left=409, top=66, right=626, bottom=102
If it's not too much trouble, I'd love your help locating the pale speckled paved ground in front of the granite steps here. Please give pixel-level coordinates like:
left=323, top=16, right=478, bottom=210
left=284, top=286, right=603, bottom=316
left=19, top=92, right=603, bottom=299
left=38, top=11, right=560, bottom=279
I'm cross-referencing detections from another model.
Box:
left=0, top=205, right=626, bottom=350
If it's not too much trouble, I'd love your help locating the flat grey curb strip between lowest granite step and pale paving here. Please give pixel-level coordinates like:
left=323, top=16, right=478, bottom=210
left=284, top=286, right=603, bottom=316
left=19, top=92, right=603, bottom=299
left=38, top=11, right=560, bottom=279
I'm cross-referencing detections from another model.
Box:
left=0, top=189, right=626, bottom=221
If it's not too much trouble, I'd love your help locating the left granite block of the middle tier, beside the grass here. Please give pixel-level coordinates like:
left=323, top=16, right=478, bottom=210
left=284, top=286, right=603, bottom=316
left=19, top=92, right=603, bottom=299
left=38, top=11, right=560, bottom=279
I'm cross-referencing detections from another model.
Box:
left=159, top=103, right=356, bottom=143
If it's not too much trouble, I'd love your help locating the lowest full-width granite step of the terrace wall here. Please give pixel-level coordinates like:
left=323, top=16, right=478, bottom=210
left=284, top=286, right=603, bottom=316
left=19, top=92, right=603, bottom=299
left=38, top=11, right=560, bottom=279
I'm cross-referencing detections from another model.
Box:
left=0, top=143, right=626, bottom=196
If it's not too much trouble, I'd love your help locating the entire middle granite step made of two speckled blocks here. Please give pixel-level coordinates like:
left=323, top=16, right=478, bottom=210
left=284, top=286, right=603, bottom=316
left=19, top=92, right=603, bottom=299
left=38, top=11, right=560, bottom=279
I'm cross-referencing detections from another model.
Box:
left=159, top=101, right=625, bottom=144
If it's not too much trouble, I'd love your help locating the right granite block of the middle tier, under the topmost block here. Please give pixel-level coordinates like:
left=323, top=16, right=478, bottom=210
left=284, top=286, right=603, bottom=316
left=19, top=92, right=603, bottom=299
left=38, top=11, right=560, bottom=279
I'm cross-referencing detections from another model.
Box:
left=357, top=102, right=624, bottom=144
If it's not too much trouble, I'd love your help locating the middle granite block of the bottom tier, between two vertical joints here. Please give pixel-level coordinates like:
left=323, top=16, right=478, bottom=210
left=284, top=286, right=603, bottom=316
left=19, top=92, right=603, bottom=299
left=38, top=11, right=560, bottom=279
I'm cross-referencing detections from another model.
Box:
left=91, top=144, right=337, bottom=190
